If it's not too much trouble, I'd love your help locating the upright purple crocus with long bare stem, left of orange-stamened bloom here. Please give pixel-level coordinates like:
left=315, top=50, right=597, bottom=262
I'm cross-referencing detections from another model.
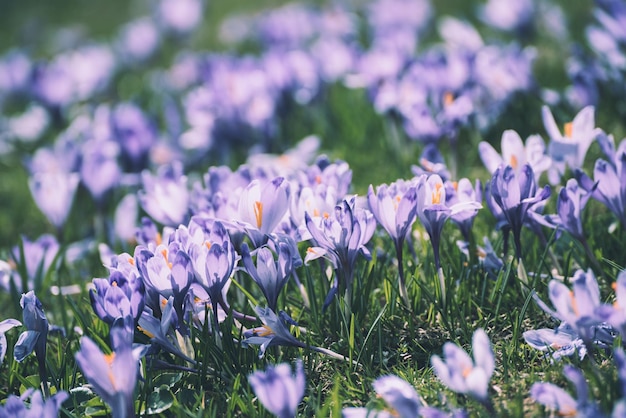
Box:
left=367, top=181, right=417, bottom=306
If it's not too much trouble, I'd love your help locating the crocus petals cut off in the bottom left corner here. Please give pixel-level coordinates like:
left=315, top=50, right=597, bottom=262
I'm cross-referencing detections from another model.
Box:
left=0, top=388, right=69, bottom=418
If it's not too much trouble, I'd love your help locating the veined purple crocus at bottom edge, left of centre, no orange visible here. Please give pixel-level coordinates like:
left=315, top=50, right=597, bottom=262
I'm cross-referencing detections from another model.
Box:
left=248, top=360, right=306, bottom=418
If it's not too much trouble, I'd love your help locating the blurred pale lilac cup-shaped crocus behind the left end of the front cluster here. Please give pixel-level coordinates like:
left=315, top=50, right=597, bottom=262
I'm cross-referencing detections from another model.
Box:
left=139, top=163, right=189, bottom=227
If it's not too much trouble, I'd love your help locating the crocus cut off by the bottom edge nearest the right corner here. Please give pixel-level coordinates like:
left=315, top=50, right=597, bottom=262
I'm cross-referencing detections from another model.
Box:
left=530, top=365, right=603, bottom=417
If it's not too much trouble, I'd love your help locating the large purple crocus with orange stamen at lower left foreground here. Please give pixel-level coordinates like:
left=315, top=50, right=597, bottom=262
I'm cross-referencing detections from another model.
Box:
left=76, top=320, right=140, bottom=418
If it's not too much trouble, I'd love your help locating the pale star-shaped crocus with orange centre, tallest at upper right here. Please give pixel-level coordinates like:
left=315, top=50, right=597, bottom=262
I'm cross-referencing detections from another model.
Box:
left=541, top=106, right=602, bottom=184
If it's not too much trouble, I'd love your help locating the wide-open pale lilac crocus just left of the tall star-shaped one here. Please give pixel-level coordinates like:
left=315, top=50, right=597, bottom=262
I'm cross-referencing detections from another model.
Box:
left=478, top=129, right=552, bottom=181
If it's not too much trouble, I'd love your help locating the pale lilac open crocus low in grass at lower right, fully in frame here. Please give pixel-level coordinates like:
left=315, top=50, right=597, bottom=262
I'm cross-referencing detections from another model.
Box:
left=430, top=329, right=495, bottom=404
